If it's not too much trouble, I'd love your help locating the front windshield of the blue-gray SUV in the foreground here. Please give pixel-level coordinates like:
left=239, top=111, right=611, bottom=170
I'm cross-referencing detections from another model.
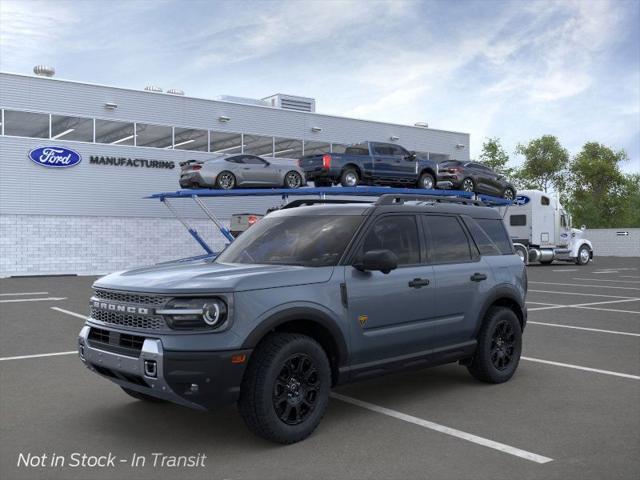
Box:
left=216, top=215, right=363, bottom=267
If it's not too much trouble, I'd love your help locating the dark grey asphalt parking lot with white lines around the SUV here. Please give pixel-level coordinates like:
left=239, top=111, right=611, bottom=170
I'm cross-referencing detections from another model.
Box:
left=0, top=257, right=640, bottom=479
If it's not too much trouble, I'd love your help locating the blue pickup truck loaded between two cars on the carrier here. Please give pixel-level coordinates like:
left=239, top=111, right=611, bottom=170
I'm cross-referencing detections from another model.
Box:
left=299, top=142, right=450, bottom=190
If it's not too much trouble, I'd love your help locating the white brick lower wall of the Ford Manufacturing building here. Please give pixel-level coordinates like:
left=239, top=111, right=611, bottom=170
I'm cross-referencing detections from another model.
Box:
left=0, top=215, right=229, bottom=277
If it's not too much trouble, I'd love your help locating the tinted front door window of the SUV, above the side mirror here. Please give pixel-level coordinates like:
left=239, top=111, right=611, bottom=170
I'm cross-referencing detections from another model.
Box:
left=361, top=215, right=420, bottom=265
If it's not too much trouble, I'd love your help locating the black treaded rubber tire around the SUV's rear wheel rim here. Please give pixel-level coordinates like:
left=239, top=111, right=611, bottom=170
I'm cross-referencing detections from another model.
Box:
left=467, top=307, right=522, bottom=383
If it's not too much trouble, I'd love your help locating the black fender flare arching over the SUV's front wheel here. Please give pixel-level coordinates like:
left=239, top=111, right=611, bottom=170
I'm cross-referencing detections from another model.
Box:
left=241, top=306, right=349, bottom=366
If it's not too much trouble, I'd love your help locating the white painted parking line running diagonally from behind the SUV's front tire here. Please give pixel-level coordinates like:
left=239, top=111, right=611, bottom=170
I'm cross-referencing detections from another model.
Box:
left=331, top=393, right=553, bottom=463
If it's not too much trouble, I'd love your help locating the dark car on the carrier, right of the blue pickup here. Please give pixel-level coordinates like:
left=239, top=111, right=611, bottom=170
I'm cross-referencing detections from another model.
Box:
left=438, top=160, right=516, bottom=200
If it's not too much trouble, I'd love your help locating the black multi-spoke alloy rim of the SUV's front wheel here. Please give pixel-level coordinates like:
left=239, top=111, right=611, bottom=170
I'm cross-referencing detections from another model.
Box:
left=273, top=353, right=320, bottom=425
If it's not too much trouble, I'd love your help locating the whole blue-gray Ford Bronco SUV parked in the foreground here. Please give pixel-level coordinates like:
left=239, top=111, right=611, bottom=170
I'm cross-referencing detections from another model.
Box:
left=79, top=195, right=527, bottom=443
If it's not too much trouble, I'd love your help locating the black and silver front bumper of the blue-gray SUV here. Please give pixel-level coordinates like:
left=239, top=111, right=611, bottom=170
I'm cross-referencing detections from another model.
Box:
left=78, top=325, right=251, bottom=410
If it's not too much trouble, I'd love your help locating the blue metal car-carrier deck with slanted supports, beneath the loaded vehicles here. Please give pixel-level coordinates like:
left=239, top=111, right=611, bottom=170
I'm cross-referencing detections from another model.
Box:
left=145, top=187, right=512, bottom=255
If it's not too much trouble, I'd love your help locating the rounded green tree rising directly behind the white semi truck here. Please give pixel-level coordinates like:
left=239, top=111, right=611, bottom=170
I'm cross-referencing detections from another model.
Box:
left=516, top=135, right=569, bottom=192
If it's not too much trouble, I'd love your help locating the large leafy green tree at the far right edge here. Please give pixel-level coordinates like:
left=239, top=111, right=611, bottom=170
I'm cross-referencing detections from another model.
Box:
left=566, top=142, right=640, bottom=228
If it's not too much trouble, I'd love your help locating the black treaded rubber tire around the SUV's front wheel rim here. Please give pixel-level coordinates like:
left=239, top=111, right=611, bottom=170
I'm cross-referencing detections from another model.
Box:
left=238, top=333, right=331, bottom=444
